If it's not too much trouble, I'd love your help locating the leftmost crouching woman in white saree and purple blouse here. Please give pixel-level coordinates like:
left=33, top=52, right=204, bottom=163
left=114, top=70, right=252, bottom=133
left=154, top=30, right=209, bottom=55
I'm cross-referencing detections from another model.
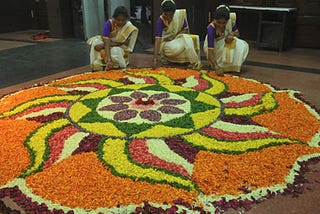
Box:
left=87, top=6, right=138, bottom=71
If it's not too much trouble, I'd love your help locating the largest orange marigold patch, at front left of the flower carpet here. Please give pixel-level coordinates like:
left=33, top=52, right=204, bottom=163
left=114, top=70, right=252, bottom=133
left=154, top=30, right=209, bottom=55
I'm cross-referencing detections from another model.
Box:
left=26, top=152, right=196, bottom=209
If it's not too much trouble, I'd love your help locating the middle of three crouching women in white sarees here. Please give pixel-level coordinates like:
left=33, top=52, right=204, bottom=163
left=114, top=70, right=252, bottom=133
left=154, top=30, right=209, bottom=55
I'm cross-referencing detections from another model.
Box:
left=153, top=0, right=201, bottom=68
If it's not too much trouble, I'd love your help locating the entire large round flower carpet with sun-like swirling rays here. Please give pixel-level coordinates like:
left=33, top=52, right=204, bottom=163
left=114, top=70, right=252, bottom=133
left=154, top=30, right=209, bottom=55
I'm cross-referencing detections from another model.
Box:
left=0, top=68, right=320, bottom=213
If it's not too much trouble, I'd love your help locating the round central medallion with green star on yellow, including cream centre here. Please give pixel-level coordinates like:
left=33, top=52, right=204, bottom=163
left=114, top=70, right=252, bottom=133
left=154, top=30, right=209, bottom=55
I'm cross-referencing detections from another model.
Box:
left=69, top=84, right=221, bottom=138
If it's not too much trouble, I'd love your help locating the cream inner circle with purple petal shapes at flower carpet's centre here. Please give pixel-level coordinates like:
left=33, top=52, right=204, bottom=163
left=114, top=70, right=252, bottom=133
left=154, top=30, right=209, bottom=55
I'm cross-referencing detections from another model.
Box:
left=97, top=90, right=190, bottom=124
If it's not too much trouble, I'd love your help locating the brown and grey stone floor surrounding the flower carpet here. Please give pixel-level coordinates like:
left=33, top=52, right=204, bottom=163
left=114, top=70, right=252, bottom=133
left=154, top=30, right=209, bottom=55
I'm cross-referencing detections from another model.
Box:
left=0, top=30, right=320, bottom=214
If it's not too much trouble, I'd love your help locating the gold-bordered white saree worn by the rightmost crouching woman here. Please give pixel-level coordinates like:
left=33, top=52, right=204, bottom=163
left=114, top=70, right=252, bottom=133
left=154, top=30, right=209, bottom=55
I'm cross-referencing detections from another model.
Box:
left=203, top=13, right=249, bottom=72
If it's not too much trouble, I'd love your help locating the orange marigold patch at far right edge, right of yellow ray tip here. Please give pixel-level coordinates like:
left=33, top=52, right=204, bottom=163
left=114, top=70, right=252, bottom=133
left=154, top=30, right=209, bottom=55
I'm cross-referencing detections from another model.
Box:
left=253, top=92, right=320, bottom=142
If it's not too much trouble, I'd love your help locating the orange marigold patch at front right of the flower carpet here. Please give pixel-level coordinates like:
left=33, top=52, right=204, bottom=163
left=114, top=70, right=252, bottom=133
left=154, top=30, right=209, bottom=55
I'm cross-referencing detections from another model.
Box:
left=192, top=144, right=320, bottom=195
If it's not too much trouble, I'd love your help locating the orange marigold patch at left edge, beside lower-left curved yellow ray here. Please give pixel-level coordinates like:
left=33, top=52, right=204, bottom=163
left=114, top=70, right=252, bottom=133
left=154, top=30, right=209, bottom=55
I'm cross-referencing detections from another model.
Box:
left=0, top=120, right=41, bottom=186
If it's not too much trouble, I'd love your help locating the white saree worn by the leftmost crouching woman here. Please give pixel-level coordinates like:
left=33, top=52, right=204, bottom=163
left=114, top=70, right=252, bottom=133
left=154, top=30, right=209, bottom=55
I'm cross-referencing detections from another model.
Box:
left=87, top=21, right=138, bottom=71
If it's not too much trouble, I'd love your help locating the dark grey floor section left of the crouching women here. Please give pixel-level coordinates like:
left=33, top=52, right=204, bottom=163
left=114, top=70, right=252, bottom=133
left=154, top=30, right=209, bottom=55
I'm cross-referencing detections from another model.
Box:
left=0, top=39, right=89, bottom=88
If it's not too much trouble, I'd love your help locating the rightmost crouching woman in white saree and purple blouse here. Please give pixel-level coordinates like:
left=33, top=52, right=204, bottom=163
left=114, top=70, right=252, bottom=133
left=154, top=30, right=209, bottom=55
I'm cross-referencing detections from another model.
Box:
left=203, top=5, right=249, bottom=76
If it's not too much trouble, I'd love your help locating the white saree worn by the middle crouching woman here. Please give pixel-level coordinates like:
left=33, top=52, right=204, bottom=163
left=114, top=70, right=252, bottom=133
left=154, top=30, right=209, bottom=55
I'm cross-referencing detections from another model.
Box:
left=160, top=9, right=200, bottom=64
